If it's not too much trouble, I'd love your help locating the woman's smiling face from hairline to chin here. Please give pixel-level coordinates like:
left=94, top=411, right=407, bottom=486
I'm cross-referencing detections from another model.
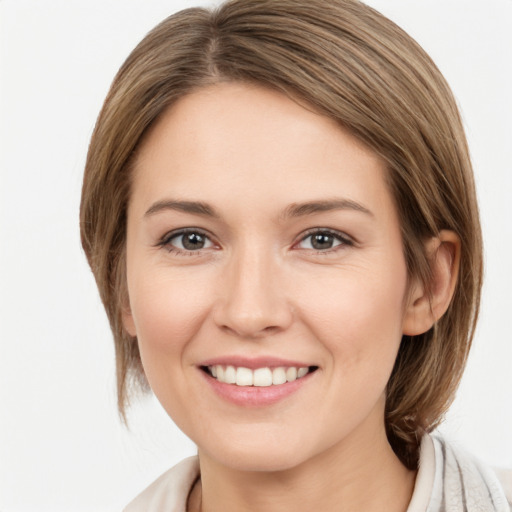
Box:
left=124, top=84, right=407, bottom=470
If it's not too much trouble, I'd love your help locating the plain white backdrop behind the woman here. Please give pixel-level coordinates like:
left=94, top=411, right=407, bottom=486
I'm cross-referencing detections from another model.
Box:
left=0, top=0, right=512, bottom=512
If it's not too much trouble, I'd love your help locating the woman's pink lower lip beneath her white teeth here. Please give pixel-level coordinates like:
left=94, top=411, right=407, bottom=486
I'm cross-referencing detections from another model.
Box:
left=200, top=370, right=316, bottom=407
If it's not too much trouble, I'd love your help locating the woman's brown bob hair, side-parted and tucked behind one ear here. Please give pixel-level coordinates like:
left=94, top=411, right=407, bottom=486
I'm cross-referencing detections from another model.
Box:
left=80, top=0, right=482, bottom=468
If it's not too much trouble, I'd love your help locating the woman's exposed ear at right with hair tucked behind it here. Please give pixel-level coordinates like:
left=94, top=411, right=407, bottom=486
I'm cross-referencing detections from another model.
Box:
left=402, top=230, right=460, bottom=336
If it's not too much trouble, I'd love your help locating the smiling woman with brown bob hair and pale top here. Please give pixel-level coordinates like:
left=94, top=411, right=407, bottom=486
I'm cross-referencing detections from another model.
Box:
left=81, top=0, right=509, bottom=512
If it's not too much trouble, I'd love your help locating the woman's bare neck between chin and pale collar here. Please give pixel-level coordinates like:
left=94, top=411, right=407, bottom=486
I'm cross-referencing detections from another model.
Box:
left=192, top=414, right=415, bottom=512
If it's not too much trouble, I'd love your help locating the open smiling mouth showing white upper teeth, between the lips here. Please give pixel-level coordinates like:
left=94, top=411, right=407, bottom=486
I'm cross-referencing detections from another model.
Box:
left=200, top=364, right=318, bottom=388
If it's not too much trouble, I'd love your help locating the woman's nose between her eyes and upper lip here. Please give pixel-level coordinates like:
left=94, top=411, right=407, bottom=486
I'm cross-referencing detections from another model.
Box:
left=214, top=247, right=293, bottom=339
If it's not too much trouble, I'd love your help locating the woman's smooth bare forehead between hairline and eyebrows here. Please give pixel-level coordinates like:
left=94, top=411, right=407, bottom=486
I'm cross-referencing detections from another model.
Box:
left=132, top=83, right=391, bottom=220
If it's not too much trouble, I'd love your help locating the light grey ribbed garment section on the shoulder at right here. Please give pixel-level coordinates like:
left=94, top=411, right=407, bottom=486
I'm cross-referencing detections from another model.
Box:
left=427, top=436, right=512, bottom=512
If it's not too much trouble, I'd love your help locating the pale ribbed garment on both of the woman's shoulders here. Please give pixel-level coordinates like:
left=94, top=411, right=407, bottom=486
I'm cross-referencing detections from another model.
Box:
left=124, top=435, right=512, bottom=512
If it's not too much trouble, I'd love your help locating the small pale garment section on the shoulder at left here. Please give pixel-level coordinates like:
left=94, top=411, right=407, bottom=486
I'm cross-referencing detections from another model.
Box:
left=123, top=457, right=199, bottom=512
